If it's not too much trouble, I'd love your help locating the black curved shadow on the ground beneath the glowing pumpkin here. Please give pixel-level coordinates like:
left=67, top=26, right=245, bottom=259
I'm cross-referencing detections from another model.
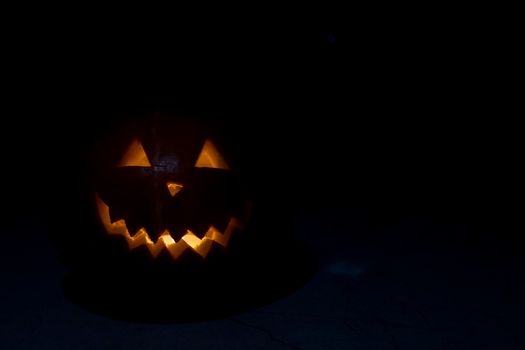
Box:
left=64, top=238, right=317, bottom=323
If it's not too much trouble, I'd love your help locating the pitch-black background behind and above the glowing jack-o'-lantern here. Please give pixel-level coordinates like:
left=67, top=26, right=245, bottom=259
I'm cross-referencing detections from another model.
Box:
left=1, top=8, right=524, bottom=348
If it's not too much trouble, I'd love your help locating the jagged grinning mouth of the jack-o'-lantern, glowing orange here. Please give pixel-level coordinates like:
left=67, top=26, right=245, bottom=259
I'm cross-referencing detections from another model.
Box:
left=96, top=194, right=244, bottom=260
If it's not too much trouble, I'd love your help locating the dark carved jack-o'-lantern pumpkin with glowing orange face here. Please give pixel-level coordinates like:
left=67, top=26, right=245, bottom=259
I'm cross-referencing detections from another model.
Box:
left=95, top=115, right=250, bottom=261
